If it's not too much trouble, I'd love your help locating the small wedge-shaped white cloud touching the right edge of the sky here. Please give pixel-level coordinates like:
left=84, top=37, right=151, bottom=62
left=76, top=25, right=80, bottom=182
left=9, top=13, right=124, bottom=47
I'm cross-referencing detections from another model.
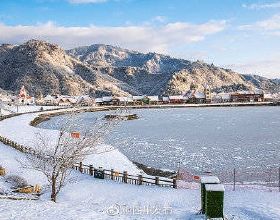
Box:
left=239, top=14, right=280, bottom=31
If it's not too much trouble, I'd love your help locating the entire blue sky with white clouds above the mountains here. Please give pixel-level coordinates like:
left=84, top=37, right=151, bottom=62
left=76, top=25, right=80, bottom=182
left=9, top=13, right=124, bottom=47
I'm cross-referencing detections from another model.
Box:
left=0, top=0, right=280, bottom=78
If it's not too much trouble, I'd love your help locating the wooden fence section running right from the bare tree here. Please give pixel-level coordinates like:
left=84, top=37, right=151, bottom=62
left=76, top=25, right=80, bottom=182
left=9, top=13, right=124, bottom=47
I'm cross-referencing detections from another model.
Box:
left=73, top=162, right=177, bottom=188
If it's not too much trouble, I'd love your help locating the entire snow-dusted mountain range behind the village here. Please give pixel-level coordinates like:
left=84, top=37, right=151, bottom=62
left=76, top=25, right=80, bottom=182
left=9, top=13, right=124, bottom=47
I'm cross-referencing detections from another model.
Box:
left=0, top=40, right=280, bottom=96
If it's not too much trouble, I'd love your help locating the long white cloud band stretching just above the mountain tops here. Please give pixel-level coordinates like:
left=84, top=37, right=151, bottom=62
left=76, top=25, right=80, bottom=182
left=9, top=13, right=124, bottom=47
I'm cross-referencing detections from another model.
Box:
left=0, top=21, right=226, bottom=53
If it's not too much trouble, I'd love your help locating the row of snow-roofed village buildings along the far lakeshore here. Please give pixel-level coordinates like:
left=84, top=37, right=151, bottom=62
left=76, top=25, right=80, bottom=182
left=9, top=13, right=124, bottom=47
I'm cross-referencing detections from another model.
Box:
left=0, top=87, right=280, bottom=106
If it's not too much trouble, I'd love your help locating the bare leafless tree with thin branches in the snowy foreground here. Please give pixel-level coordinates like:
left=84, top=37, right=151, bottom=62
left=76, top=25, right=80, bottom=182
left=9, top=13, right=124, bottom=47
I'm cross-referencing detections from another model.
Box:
left=24, top=113, right=118, bottom=202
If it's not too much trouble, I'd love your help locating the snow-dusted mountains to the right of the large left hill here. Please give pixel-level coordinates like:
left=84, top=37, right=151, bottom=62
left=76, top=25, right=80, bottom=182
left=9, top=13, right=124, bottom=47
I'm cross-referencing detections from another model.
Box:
left=67, top=44, right=280, bottom=95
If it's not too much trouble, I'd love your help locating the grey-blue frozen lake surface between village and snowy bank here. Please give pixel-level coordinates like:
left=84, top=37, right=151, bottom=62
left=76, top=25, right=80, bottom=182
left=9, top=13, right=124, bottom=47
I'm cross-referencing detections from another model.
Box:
left=39, top=107, right=280, bottom=180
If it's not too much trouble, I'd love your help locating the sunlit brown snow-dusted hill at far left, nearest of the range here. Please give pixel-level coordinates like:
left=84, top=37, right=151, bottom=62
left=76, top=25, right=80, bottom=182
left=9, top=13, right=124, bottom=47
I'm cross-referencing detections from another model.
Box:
left=0, top=40, right=136, bottom=95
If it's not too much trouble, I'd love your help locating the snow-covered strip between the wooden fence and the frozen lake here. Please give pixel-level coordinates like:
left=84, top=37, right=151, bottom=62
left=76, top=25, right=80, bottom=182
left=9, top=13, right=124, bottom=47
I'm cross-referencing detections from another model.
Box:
left=0, top=109, right=141, bottom=174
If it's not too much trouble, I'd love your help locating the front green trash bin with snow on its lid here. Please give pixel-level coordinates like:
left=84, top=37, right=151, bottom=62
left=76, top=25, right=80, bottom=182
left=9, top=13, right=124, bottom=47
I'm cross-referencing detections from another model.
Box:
left=205, top=184, right=225, bottom=218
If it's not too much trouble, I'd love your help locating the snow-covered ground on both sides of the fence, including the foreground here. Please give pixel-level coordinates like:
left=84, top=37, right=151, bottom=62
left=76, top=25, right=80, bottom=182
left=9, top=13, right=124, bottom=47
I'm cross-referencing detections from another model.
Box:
left=0, top=109, right=280, bottom=220
